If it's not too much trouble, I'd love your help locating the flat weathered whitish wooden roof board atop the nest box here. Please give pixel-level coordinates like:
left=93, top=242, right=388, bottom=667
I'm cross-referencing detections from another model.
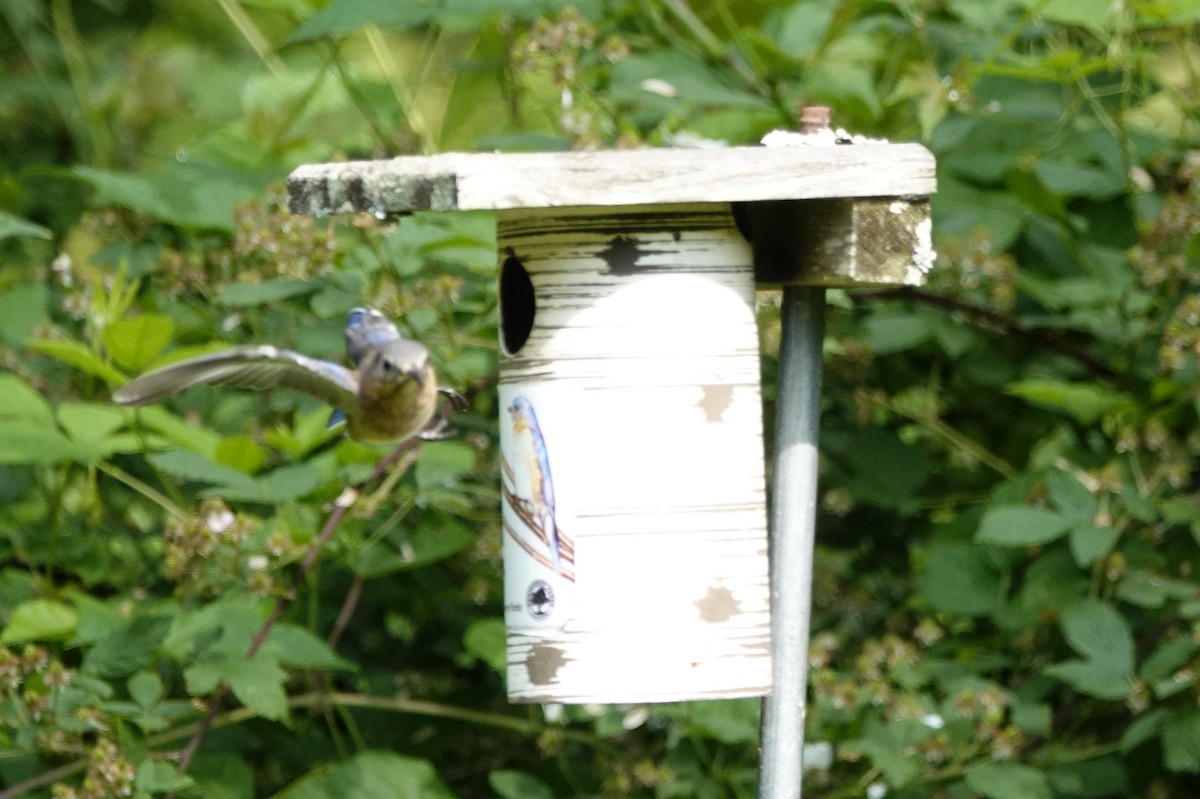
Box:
left=288, top=144, right=936, bottom=216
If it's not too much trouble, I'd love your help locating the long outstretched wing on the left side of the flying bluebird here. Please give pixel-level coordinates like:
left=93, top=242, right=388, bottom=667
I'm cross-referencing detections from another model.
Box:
left=113, top=344, right=358, bottom=408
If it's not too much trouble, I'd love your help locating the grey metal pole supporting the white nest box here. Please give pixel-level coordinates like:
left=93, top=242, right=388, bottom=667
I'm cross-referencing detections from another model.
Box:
left=758, top=287, right=824, bottom=799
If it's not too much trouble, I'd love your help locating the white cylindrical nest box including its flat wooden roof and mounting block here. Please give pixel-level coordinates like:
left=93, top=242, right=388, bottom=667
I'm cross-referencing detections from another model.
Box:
left=289, top=145, right=934, bottom=702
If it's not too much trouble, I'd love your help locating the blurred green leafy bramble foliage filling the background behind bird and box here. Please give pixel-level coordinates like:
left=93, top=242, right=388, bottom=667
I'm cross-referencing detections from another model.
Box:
left=0, top=0, right=1200, bottom=799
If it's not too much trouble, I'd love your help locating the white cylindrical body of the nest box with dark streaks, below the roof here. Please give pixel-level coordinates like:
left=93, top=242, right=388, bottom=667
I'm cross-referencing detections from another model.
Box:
left=499, top=204, right=770, bottom=702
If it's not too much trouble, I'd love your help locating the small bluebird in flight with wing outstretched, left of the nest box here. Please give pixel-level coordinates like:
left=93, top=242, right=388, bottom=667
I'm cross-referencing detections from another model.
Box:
left=113, top=308, right=441, bottom=444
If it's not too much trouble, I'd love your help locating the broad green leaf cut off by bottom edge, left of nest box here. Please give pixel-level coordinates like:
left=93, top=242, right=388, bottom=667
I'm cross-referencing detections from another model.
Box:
left=274, top=751, right=454, bottom=799
